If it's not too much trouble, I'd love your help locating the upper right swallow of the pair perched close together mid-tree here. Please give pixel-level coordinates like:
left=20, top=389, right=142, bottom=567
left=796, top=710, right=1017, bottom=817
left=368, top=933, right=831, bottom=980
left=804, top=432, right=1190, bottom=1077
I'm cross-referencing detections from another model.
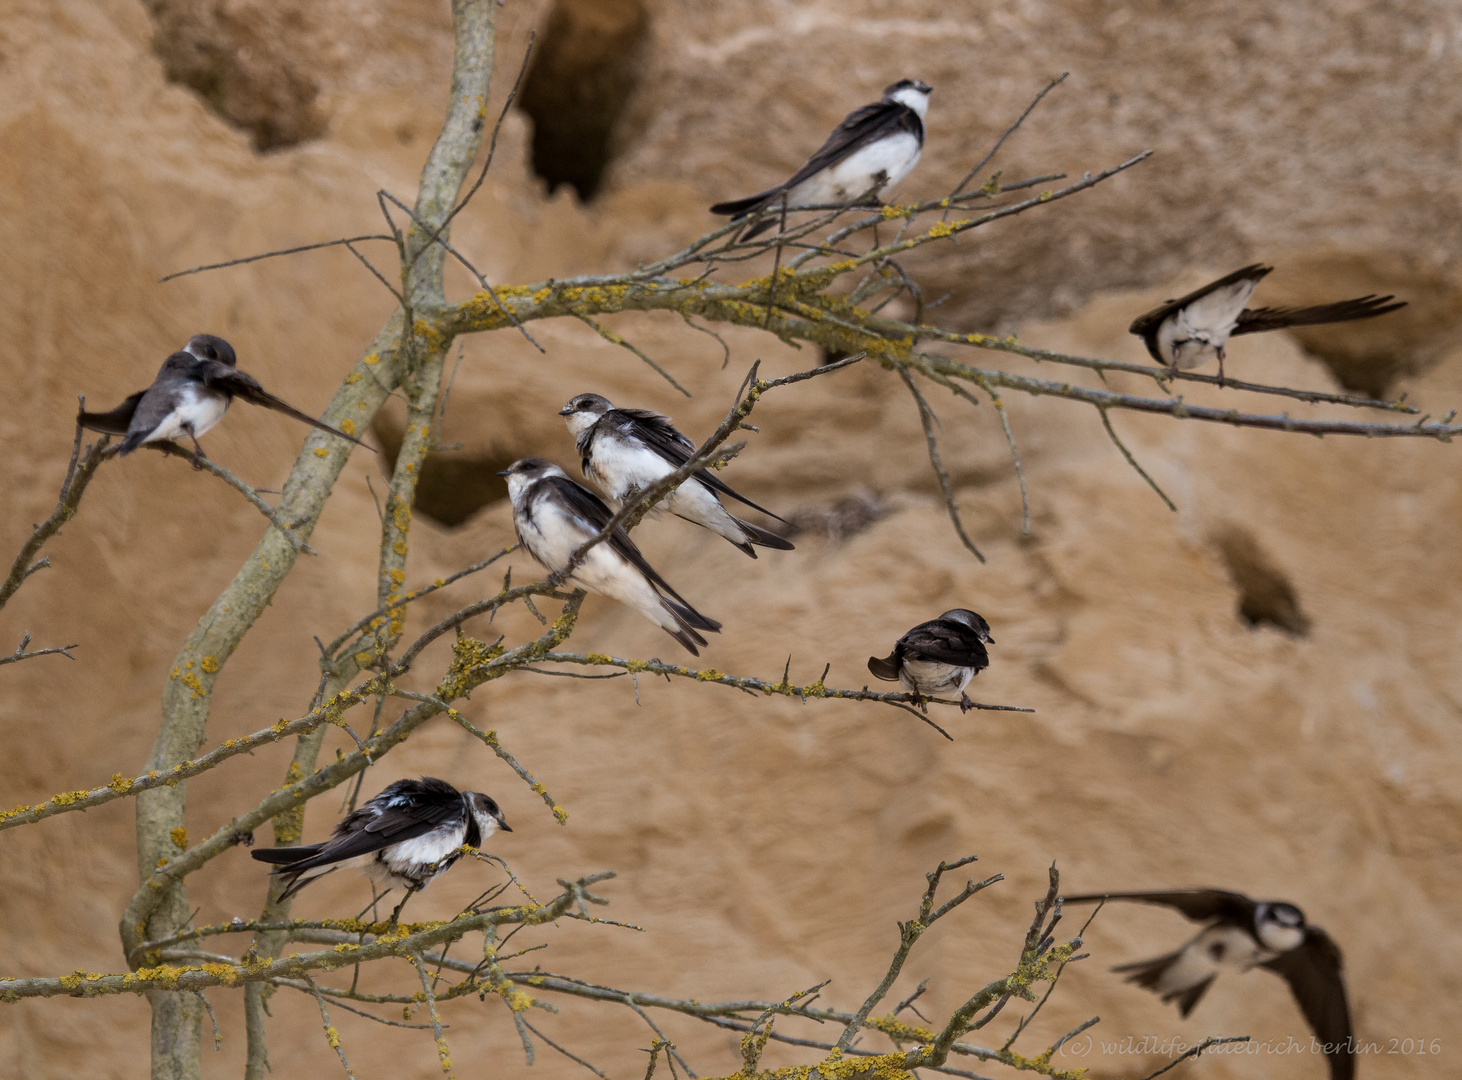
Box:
left=558, top=393, right=792, bottom=558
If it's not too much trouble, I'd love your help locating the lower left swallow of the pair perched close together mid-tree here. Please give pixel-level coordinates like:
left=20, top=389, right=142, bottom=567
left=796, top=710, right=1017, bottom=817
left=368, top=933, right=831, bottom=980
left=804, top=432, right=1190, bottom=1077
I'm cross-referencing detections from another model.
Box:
left=499, top=457, right=721, bottom=656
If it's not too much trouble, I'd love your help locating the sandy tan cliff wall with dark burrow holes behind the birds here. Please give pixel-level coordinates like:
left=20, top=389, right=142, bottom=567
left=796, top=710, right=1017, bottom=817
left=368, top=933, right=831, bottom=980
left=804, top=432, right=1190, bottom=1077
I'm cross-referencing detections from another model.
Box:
left=0, top=0, right=1462, bottom=1079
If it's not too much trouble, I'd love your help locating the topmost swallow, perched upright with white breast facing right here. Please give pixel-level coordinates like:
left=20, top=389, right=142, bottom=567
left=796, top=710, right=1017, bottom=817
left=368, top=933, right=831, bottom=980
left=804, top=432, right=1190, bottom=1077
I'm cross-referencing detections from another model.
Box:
left=711, top=79, right=933, bottom=240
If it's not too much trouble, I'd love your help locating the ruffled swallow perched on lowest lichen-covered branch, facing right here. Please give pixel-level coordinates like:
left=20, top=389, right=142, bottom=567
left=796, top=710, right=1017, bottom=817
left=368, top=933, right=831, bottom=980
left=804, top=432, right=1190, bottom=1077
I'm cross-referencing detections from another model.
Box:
left=250, top=776, right=513, bottom=910
